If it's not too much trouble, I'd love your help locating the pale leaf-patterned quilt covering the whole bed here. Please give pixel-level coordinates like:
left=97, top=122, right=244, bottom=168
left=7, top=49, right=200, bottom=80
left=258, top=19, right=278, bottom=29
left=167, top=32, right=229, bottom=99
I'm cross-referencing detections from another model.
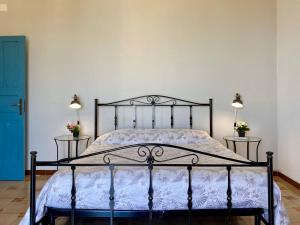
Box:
left=20, top=129, right=289, bottom=225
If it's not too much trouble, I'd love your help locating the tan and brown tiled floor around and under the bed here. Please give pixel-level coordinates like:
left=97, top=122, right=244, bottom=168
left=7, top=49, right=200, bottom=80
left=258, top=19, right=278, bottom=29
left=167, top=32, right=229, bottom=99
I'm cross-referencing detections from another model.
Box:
left=0, top=176, right=300, bottom=225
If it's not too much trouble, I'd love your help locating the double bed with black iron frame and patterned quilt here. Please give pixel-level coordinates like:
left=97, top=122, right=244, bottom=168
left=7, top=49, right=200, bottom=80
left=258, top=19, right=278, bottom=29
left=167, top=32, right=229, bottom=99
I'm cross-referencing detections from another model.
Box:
left=20, top=95, right=288, bottom=225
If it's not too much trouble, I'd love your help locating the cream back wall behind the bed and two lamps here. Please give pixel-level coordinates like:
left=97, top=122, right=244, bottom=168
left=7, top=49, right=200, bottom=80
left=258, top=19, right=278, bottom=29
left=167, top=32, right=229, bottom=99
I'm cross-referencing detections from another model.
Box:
left=0, top=0, right=277, bottom=169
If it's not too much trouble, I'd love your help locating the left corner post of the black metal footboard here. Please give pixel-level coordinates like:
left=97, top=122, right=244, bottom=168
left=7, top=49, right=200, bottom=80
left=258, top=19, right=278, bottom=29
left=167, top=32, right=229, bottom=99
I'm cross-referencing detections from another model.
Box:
left=30, top=152, right=37, bottom=225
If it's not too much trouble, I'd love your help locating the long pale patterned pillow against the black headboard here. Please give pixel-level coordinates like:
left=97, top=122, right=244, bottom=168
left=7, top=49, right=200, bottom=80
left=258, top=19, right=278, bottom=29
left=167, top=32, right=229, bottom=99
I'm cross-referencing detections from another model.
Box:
left=95, top=129, right=210, bottom=145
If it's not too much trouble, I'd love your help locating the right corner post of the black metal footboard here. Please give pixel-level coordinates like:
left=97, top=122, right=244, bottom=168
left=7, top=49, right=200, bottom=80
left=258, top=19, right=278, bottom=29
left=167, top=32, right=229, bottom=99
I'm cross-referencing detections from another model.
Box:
left=267, top=152, right=274, bottom=225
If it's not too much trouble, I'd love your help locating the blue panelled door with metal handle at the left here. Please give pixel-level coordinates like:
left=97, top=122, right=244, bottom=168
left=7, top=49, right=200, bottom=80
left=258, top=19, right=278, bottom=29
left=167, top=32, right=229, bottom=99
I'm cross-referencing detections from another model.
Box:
left=0, top=36, right=26, bottom=180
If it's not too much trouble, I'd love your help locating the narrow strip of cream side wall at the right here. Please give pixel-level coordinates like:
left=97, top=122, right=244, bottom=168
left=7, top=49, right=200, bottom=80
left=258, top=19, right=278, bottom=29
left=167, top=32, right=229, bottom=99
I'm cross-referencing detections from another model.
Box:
left=277, top=0, right=300, bottom=183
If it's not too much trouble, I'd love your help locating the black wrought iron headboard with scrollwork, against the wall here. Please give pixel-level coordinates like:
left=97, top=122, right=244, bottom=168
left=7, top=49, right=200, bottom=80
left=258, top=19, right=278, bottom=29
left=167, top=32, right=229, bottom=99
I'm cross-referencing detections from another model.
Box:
left=94, top=95, right=213, bottom=139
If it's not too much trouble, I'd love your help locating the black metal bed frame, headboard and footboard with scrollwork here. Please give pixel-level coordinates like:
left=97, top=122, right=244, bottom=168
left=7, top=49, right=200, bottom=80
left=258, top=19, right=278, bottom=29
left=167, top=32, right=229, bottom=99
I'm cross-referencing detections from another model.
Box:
left=30, top=95, right=274, bottom=225
